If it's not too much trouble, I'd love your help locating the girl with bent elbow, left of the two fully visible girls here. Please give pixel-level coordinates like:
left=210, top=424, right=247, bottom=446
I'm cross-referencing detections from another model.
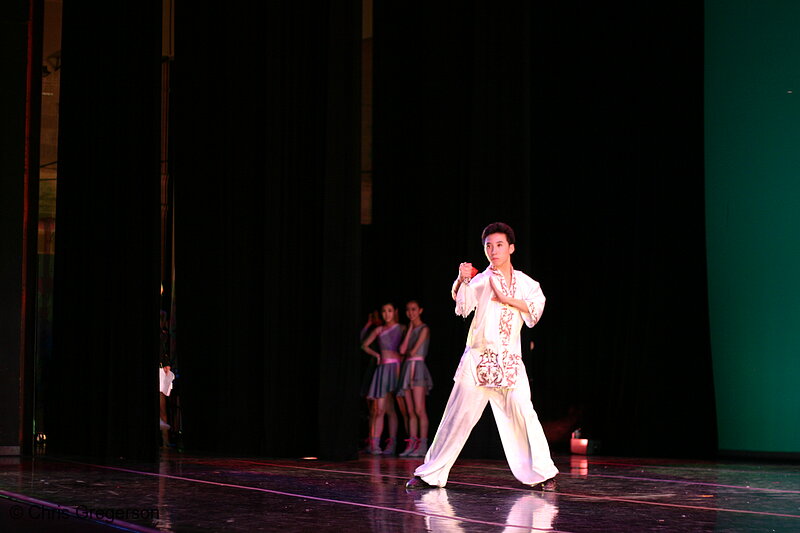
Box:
left=361, top=303, right=405, bottom=455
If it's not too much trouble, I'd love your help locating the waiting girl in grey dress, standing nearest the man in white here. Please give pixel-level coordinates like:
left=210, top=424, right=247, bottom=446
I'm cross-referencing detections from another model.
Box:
left=397, top=300, right=433, bottom=457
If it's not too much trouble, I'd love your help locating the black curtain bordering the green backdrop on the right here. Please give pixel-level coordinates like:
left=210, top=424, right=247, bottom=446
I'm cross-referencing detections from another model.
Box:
left=533, top=2, right=716, bottom=456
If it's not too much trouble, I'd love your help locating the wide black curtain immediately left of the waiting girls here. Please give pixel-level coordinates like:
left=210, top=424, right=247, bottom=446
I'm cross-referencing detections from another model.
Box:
left=171, top=1, right=361, bottom=458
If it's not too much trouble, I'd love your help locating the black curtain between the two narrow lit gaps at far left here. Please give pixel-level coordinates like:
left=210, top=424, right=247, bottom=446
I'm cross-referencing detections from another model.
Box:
left=47, top=0, right=161, bottom=458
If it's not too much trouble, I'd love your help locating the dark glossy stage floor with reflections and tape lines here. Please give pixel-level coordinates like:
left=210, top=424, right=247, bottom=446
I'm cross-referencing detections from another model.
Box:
left=0, top=452, right=800, bottom=533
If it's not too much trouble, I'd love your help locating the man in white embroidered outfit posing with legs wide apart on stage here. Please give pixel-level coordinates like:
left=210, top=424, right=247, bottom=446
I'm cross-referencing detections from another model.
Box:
left=406, top=222, right=558, bottom=491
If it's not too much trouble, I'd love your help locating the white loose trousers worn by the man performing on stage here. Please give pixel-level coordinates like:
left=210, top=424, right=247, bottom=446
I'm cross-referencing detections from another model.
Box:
left=414, top=370, right=558, bottom=487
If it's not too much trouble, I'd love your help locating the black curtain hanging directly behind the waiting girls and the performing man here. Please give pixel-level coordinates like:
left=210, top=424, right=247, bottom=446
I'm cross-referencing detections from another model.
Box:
left=364, top=2, right=546, bottom=457
